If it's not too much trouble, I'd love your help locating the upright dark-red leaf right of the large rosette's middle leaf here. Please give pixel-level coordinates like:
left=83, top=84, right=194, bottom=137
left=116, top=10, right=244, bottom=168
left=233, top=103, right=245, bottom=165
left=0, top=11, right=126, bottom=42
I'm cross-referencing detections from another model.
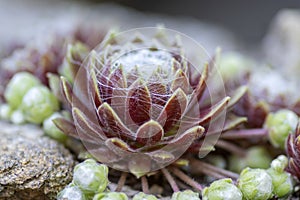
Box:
left=157, top=88, right=188, bottom=136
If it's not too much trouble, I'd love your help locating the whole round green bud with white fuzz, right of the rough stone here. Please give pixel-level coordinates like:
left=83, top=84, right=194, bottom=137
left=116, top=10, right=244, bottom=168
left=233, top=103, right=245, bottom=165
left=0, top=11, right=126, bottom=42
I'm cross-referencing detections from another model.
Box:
left=73, top=159, right=109, bottom=194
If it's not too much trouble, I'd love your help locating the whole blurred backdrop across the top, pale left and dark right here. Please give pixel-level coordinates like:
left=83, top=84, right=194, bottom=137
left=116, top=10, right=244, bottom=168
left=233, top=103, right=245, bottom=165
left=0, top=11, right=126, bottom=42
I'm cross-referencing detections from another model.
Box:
left=0, top=0, right=300, bottom=56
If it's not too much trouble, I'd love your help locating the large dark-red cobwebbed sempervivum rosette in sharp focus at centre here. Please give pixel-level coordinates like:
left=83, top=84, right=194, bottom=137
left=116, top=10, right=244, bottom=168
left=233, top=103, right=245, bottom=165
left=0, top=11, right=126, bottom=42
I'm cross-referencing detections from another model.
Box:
left=54, top=28, right=244, bottom=191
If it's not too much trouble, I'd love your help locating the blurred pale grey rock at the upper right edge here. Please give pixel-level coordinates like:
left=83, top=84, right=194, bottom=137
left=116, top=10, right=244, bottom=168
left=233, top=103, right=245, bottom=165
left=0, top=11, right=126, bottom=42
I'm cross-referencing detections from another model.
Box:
left=263, top=9, right=300, bottom=79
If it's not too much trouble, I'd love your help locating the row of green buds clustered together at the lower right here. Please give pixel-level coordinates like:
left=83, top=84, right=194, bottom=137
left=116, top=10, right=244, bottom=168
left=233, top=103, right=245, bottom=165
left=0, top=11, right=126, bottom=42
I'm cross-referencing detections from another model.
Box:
left=202, top=155, right=294, bottom=200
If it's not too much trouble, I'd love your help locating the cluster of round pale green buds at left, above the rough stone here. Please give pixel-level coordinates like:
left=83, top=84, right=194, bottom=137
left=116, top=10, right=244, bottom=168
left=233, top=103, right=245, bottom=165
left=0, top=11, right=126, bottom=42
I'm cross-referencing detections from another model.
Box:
left=0, top=72, right=60, bottom=124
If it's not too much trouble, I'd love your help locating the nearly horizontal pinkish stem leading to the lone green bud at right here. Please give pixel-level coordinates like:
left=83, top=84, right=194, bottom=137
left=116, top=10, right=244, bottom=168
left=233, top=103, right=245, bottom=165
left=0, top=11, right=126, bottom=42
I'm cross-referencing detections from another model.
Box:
left=221, top=128, right=268, bottom=140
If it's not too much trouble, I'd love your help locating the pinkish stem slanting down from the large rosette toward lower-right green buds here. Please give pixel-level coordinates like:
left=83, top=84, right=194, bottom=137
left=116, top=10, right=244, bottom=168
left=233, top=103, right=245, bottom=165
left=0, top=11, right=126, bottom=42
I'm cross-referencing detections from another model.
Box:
left=190, top=159, right=239, bottom=180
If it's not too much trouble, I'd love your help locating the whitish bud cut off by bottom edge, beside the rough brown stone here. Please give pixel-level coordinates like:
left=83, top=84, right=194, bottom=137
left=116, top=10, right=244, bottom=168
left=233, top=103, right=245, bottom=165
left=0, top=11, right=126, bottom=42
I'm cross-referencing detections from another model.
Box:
left=57, top=184, right=86, bottom=200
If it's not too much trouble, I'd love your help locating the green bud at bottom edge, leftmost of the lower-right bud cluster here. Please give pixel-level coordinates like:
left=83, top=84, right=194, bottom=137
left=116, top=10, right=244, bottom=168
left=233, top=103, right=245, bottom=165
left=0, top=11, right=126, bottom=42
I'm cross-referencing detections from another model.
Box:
left=202, top=178, right=243, bottom=200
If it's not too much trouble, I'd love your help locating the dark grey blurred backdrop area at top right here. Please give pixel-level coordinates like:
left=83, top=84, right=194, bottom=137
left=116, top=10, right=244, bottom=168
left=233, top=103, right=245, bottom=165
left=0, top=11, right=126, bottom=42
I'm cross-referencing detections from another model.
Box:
left=119, top=0, right=300, bottom=43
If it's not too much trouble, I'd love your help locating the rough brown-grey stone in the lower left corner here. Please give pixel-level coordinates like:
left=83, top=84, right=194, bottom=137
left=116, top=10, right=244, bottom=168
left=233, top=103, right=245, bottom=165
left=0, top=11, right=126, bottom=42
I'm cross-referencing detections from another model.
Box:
left=0, top=122, right=75, bottom=200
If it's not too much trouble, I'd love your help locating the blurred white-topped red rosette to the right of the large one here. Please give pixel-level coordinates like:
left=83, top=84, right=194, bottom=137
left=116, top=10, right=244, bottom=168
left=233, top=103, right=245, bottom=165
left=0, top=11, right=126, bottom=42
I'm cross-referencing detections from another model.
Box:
left=234, top=67, right=300, bottom=128
